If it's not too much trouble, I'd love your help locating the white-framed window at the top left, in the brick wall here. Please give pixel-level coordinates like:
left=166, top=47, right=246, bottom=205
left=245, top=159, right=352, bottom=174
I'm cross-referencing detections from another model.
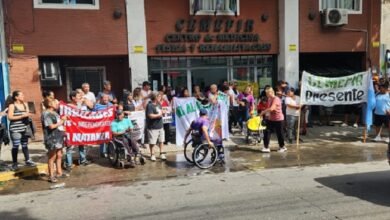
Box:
left=34, top=0, right=99, bottom=10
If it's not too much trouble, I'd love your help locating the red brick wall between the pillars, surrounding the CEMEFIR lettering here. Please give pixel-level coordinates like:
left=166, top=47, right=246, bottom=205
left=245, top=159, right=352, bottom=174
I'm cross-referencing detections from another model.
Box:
left=145, top=0, right=279, bottom=56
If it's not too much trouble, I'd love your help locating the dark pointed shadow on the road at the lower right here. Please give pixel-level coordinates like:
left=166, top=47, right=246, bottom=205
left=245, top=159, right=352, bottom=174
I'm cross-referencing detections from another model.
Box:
left=315, top=170, right=390, bottom=206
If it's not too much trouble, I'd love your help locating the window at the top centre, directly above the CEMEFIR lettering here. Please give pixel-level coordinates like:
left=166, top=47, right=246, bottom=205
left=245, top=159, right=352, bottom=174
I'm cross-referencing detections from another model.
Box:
left=190, top=0, right=240, bottom=16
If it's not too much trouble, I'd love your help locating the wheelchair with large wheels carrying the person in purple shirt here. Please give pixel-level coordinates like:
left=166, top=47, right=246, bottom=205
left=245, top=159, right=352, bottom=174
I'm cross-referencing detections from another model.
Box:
left=184, top=132, right=225, bottom=169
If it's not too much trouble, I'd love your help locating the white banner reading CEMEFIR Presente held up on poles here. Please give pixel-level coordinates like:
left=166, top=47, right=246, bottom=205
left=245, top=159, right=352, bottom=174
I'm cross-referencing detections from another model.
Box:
left=301, top=71, right=369, bottom=106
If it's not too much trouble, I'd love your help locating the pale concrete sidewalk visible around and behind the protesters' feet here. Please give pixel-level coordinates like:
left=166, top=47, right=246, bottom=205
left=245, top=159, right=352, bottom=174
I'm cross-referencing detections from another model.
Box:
left=0, top=126, right=387, bottom=182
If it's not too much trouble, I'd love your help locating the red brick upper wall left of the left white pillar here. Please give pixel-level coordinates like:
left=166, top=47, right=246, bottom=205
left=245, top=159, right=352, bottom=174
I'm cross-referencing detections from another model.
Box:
left=4, top=0, right=127, bottom=56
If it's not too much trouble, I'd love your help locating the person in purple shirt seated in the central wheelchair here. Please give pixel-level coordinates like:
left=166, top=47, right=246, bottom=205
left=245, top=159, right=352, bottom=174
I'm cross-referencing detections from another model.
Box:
left=183, top=109, right=214, bottom=146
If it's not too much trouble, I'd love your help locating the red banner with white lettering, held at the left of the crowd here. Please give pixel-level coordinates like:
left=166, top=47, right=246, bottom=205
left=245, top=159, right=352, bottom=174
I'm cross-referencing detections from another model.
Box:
left=60, top=102, right=115, bottom=146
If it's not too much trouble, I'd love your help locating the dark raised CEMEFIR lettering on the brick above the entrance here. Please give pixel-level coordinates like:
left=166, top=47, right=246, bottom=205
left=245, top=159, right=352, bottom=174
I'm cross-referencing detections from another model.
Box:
left=155, top=18, right=271, bottom=54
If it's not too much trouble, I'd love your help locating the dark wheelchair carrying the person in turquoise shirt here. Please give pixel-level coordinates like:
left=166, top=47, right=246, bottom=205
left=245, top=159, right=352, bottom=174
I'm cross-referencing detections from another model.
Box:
left=107, top=134, right=145, bottom=169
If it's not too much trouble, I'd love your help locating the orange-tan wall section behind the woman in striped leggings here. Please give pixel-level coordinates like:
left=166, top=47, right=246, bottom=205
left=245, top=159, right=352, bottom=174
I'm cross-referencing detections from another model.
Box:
left=9, top=57, right=42, bottom=139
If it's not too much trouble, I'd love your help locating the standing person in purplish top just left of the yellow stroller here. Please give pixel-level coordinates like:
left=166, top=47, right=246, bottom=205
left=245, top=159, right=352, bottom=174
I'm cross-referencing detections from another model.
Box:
left=237, top=86, right=255, bottom=132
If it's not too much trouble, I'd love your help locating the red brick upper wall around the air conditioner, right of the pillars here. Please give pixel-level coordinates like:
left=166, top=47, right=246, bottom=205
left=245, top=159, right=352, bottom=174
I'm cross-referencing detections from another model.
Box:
left=299, top=0, right=381, bottom=68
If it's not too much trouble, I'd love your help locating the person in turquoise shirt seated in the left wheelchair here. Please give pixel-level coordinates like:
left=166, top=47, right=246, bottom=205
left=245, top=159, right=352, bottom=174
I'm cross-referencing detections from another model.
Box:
left=111, top=110, right=140, bottom=167
